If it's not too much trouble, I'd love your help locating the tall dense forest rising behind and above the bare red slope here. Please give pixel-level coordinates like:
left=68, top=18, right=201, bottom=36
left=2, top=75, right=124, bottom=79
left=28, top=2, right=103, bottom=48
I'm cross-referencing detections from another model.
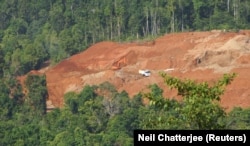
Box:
left=0, top=0, right=250, bottom=75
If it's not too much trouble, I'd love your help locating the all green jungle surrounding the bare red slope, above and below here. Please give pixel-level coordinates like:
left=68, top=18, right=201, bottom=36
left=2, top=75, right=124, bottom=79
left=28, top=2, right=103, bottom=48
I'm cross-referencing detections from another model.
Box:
left=0, top=0, right=250, bottom=146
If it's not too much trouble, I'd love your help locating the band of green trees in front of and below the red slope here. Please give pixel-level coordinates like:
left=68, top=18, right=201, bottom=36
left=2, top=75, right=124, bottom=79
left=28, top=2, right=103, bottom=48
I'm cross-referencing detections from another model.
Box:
left=0, top=77, right=249, bottom=146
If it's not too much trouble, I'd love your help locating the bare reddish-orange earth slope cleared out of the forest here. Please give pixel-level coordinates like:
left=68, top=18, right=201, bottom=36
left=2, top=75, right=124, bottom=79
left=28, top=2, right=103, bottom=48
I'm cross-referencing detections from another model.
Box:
left=20, top=30, right=250, bottom=110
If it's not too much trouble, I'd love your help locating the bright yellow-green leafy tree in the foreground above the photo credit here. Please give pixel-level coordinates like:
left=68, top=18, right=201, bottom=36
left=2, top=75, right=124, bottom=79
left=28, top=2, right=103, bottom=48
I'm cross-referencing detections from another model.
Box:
left=145, top=73, right=236, bottom=129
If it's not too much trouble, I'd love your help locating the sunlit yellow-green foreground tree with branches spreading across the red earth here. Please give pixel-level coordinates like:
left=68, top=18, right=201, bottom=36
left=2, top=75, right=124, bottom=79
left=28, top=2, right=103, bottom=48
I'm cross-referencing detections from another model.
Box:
left=144, top=73, right=236, bottom=129
